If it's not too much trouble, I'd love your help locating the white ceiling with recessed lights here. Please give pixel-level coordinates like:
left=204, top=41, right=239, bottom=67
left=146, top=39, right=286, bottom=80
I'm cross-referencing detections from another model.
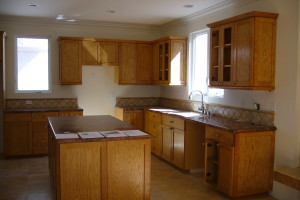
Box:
left=0, top=0, right=230, bottom=25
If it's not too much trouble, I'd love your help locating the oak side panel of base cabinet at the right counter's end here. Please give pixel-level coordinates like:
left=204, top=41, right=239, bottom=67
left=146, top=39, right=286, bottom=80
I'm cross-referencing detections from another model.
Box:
left=234, top=132, right=274, bottom=196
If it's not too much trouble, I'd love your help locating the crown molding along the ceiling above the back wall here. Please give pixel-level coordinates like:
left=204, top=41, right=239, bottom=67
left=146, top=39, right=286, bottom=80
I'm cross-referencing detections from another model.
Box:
left=0, top=15, right=160, bottom=31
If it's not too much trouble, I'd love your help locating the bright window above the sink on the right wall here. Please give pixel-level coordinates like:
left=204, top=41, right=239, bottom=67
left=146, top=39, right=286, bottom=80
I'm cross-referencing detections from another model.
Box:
left=189, top=29, right=224, bottom=97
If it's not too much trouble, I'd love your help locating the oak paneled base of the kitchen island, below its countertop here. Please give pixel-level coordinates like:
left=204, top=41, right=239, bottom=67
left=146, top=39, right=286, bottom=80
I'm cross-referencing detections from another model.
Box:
left=49, top=138, right=151, bottom=200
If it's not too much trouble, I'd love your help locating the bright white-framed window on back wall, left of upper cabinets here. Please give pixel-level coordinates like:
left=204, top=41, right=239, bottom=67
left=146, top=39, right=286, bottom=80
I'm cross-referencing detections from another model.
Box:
left=16, top=37, right=50, bottom=93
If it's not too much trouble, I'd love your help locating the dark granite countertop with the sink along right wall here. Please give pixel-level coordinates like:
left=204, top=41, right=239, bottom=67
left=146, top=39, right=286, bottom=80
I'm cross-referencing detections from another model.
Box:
left=148, top=108, right=276, bottom=133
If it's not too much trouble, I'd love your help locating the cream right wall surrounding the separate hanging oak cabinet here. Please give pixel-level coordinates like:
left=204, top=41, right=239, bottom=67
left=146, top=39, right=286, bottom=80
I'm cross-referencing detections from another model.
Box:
left=161, top=0, right=300, bottom=199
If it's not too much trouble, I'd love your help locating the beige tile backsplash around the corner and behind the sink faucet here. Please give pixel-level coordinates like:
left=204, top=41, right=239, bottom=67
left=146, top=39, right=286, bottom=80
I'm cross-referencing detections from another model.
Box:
left=116, top=97, right=275, bottom=126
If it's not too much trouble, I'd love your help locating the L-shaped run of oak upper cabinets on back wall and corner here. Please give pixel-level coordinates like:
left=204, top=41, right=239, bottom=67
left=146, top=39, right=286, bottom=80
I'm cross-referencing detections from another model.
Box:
left=58, top=36, right=187, bottom=86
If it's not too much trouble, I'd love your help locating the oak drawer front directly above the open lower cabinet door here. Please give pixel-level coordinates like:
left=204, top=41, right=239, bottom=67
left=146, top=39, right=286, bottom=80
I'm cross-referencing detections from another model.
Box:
left=205, top=126, right=234, bottom=146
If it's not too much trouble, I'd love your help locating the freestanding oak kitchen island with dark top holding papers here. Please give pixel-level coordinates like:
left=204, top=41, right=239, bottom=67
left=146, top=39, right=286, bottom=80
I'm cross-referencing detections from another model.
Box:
left=48, top=115, right=151, bottom=200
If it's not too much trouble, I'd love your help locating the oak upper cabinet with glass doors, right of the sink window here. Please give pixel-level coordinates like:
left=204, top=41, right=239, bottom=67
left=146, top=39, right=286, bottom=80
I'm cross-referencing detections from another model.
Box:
left=207, top=11, right=278, bottom=90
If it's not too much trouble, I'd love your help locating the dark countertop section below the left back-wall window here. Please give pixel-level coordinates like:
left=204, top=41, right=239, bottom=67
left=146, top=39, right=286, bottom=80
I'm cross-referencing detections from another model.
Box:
left=4, top=107, right=83, bottom=113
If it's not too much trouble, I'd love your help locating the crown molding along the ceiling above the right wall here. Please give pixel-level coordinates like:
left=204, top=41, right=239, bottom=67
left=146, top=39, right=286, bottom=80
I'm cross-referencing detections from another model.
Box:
left=160, top=0, right=258, bottom=31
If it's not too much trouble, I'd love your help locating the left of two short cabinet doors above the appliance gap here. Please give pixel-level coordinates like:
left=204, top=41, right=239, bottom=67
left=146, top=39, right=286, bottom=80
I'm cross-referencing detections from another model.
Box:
left=82, top=40, right=99, bottom=65
